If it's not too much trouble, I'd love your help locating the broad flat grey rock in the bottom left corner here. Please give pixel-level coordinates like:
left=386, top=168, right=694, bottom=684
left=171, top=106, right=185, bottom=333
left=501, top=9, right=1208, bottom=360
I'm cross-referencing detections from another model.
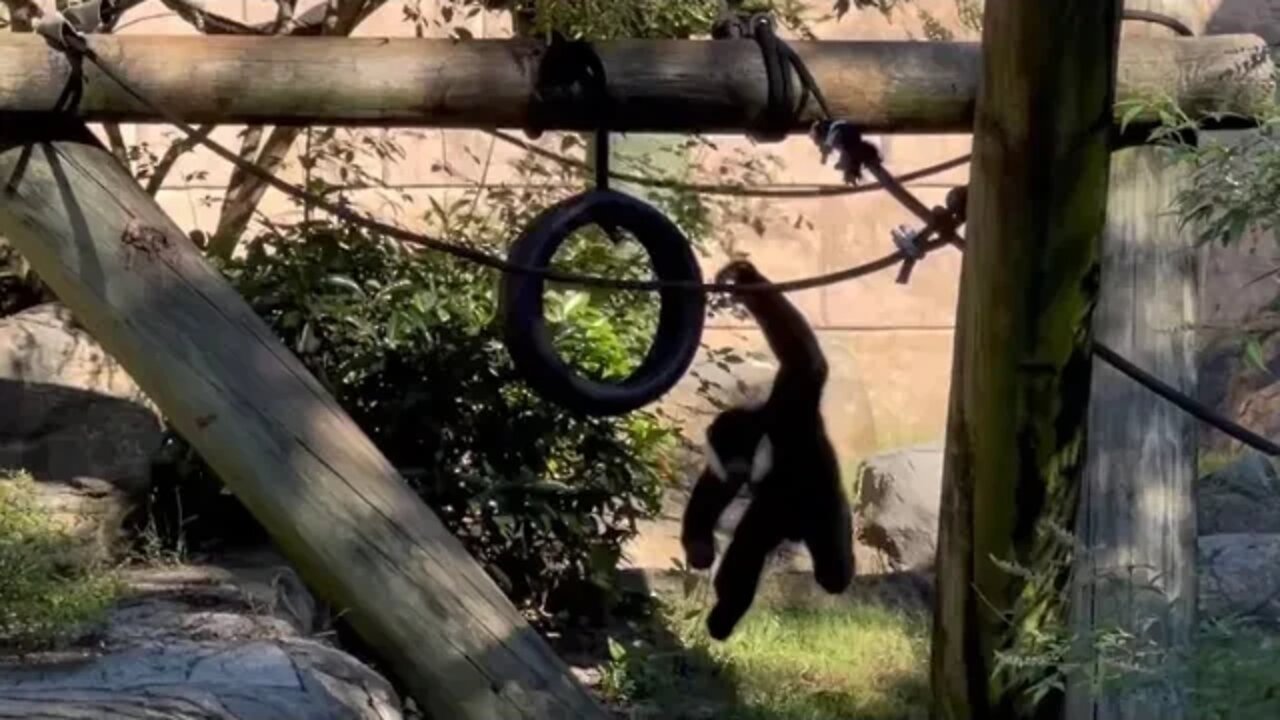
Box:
left=0, top=545, right=402, bottom=720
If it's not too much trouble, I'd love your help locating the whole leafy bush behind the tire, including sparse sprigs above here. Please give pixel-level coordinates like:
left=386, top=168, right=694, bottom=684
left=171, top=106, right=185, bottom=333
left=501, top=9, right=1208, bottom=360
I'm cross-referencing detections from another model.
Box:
left=147, top=120, right=757, bottom=614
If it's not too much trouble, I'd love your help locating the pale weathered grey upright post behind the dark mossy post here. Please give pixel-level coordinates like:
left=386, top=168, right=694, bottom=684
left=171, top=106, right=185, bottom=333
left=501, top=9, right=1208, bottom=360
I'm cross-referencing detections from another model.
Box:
left=1066, top=0, right=1208, bottom=720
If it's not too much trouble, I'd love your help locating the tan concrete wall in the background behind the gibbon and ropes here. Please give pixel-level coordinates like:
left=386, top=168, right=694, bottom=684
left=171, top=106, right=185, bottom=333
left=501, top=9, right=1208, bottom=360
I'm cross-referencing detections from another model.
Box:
left=97, top=0, right=1280, bottom=474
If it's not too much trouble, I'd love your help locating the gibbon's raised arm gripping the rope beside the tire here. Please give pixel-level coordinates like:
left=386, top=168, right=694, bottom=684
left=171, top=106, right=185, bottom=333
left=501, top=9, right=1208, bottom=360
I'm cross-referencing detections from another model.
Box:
left=719, top=260, right=828, bottom=391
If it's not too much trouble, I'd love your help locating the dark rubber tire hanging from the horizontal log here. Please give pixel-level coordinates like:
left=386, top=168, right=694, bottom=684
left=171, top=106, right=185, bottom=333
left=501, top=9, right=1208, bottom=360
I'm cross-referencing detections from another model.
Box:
left=498, top=190, right=707, bottom=416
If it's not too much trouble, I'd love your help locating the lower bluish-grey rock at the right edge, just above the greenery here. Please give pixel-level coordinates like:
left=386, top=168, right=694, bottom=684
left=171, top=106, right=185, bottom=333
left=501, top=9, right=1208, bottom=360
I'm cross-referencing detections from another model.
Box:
left=1197, top=533, right=1280, bottom=621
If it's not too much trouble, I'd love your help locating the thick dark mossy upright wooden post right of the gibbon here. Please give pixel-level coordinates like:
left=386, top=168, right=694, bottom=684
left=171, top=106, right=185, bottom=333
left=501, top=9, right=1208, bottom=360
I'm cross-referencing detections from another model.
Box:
left=932, top=0, right=1120, bottom=720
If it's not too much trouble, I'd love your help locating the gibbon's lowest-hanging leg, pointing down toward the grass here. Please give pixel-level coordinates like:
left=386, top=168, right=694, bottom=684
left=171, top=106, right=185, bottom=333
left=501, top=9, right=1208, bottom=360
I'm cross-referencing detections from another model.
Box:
left=707, top=500, right=782, bottom=641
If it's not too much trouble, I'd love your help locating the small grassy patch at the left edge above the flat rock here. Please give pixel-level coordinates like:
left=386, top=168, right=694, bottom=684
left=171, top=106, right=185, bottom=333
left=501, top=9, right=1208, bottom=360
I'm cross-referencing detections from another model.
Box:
left=0, top=471, right=120, bottom=652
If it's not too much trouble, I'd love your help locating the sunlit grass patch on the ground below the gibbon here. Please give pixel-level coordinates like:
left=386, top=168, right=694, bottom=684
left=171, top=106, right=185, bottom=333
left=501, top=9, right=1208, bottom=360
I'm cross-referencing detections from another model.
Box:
left=602, top=589, right=928, bottom=720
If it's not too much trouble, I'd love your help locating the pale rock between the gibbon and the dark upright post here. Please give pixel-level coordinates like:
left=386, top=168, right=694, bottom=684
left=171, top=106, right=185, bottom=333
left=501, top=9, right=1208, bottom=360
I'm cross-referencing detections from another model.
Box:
left=854, top=445, right=943, bottom=573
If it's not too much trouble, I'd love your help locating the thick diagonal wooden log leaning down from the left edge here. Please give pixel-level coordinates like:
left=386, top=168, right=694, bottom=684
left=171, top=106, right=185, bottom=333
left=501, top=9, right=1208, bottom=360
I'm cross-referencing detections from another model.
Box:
left=0, top=117, right=607, bottom=720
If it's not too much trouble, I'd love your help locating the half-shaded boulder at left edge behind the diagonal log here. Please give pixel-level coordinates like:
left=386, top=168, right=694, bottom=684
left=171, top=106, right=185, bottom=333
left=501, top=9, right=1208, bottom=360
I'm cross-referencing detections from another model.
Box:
left=0, top=304, right=163, bottom=555
